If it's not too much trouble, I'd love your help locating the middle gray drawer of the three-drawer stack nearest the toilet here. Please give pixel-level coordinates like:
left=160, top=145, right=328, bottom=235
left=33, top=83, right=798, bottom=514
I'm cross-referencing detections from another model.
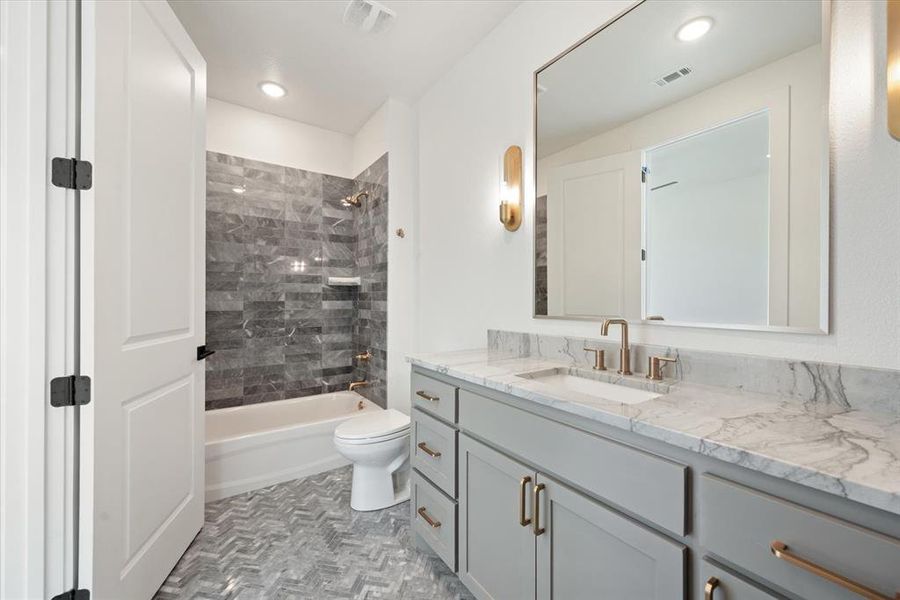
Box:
left=410, top=409, right=456, bottom=498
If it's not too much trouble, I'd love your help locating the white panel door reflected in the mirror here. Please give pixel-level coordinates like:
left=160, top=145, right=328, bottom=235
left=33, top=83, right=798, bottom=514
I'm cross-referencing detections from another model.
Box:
left=547, top=152, right=641, bottom=317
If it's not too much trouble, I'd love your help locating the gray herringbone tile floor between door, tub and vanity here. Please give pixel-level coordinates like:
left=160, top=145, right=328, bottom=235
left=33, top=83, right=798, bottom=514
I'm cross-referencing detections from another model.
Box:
left=156, top=467, right=472, bottom=600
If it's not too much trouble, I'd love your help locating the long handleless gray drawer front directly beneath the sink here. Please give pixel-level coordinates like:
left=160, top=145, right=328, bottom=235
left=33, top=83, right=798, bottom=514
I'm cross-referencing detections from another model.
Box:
left=459, top=390, right=688, bottom=535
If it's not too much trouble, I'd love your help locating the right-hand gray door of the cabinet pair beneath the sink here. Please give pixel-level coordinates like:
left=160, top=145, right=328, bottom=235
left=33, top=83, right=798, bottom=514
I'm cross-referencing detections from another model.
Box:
left=535, top=473, right=685, bottom=600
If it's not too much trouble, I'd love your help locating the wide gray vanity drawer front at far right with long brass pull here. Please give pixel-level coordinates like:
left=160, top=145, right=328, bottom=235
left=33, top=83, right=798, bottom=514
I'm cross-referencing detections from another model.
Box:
left=699, top=474, right=900, bottom=600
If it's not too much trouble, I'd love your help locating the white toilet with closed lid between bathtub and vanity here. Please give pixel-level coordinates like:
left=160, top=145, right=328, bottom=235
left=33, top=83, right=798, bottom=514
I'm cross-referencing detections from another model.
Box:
left=334, top=408, right=409, bottom=511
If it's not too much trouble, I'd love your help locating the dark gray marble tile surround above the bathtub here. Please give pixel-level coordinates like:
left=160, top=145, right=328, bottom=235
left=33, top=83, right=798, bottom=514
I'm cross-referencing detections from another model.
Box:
left=206, top=152, right=387, bottom=409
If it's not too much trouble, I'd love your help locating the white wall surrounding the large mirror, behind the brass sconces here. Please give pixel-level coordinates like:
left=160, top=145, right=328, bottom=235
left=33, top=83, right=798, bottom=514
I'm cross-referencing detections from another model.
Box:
left=418, top=0, right=900, bottom=367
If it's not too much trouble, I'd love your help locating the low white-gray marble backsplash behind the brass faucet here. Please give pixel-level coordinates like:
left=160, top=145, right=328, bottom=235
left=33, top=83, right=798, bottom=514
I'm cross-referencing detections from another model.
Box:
left=487, top=329, right=900, bottom=414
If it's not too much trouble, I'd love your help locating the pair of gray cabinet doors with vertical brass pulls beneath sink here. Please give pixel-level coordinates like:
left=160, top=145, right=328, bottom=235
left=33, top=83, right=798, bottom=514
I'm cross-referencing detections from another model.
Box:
left=459, top=434, right=686, bottom=600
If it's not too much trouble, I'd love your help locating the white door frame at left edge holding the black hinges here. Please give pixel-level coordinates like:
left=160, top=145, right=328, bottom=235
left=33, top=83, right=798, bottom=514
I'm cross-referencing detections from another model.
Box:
left=0, top=0, right=79, bottom=598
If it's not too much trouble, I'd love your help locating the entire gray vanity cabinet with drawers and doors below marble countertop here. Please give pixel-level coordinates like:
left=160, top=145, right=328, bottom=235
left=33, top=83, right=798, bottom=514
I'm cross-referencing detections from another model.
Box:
left=411, top=369, right=900, bottom=600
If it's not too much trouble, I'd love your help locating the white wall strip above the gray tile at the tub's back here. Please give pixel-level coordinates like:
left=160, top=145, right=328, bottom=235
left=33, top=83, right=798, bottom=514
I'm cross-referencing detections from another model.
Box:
left=206, top=98, right=356, bottom=178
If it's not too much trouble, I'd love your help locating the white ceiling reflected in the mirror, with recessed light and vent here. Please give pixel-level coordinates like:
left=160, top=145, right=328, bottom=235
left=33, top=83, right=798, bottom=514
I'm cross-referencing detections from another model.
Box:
left=538, top=0, right=822, bottom=156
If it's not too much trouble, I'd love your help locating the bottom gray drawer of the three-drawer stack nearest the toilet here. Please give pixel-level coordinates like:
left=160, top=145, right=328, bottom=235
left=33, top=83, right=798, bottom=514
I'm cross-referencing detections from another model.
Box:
left=412, top=471, right=456, bottom=572
